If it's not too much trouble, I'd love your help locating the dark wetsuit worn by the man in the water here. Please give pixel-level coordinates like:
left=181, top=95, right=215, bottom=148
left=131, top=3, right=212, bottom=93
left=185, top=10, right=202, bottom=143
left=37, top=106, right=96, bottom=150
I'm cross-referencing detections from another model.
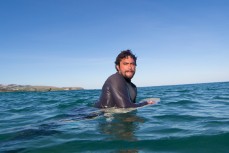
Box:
left=95, top=72, right=147, bottom=108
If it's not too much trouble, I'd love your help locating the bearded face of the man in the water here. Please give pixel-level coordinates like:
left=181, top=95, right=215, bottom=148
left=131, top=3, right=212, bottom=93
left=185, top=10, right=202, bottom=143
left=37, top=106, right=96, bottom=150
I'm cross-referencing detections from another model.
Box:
left=116, top=56, right=136, bottom=79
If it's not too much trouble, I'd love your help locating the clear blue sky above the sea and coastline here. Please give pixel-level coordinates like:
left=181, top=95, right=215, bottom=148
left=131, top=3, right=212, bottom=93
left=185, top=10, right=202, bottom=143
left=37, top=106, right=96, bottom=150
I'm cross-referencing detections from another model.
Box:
left=0, top=0, right=229, bottom=89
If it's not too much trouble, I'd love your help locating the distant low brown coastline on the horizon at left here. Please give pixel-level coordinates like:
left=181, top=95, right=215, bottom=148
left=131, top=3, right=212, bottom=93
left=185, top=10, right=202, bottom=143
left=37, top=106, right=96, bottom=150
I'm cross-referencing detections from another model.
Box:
left=0, top=84, right=83, bottom=92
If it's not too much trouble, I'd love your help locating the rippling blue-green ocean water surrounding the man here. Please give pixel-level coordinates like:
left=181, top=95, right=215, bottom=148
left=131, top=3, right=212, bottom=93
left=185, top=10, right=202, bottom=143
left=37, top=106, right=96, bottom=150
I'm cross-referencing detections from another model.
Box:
left=0, top=82, right=229, bottom=153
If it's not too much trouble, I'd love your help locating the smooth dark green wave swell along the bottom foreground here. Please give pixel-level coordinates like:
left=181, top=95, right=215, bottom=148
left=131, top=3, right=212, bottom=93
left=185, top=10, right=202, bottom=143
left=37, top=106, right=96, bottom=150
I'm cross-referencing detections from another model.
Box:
left=8, top=133, right=229, bottom=153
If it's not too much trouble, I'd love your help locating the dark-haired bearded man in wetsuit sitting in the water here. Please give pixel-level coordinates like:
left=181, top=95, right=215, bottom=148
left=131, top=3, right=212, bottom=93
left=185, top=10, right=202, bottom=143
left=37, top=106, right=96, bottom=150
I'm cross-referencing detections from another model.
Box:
left=95, top=50, right=155, bottom=108
